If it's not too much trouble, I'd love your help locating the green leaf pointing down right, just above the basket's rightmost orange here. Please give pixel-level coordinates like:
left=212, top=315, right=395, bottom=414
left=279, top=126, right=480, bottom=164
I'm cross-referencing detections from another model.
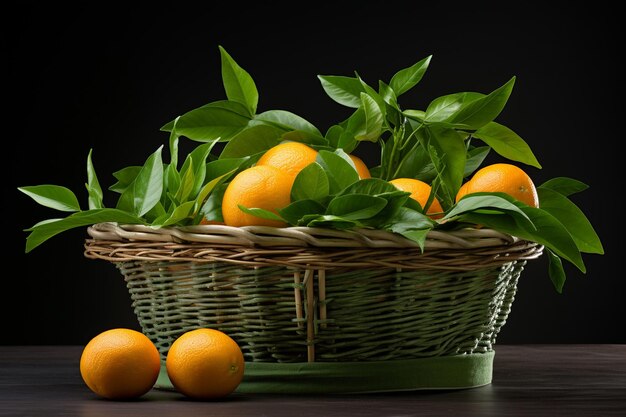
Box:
left=473, top=122, right=541, bottom=168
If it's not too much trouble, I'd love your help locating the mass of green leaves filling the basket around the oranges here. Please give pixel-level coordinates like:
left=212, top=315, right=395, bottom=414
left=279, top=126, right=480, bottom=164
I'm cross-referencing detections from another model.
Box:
left=19, top=46, right=604, bottom=292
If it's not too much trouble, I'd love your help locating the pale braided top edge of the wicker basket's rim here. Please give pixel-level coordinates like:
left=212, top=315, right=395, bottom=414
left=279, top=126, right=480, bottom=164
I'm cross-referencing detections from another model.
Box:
left=87, top=222, right=523, bottom=251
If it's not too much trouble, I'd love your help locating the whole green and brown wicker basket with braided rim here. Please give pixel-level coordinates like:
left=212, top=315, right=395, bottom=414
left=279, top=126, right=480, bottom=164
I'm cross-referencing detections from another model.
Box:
left=85, top=223, right=543, bottom=393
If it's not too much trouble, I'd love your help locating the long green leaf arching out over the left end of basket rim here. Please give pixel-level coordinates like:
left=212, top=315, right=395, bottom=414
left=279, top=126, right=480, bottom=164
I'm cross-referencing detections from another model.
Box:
left=26, top=208, right=144, bottom=253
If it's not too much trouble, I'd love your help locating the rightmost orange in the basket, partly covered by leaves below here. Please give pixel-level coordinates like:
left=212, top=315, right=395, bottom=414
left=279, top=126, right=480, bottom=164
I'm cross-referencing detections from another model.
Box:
left=456, top=164, right=539, bottom=207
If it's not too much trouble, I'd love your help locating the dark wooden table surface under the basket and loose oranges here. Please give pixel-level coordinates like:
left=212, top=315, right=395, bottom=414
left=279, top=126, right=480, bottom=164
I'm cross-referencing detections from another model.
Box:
left=0, top=345, right=626, bottom=417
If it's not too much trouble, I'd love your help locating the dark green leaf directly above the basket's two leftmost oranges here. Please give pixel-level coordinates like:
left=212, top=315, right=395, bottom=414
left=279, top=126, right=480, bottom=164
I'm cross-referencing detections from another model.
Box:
left=219, top=125, right=281, bottom=159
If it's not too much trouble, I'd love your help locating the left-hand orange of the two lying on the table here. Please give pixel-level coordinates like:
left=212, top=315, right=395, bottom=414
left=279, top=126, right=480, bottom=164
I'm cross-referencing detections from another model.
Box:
left=80, top=329, right=161, bottom=400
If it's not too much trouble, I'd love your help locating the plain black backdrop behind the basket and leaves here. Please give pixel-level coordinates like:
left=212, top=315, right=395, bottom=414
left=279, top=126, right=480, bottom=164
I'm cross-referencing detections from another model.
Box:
left=0, top=2, right=626, bottom=344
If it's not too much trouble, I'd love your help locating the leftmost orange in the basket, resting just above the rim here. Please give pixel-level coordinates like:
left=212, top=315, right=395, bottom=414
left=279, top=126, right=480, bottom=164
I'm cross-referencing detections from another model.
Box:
left=222, top=165, right=295, bottom=227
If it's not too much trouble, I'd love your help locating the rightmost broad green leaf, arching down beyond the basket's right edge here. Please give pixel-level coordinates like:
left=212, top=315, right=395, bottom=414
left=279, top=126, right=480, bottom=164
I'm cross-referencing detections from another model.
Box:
left=537, top=187, right=604, bottom=254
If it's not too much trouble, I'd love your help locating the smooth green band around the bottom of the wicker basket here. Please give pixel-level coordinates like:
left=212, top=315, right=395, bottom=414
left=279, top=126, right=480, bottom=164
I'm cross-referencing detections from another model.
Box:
left=155, top=351, right=494, bottom=394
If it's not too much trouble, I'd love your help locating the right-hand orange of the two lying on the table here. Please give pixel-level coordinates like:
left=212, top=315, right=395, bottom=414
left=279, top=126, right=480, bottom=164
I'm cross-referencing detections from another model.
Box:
left=166, top=329, right=244, bottom=399
